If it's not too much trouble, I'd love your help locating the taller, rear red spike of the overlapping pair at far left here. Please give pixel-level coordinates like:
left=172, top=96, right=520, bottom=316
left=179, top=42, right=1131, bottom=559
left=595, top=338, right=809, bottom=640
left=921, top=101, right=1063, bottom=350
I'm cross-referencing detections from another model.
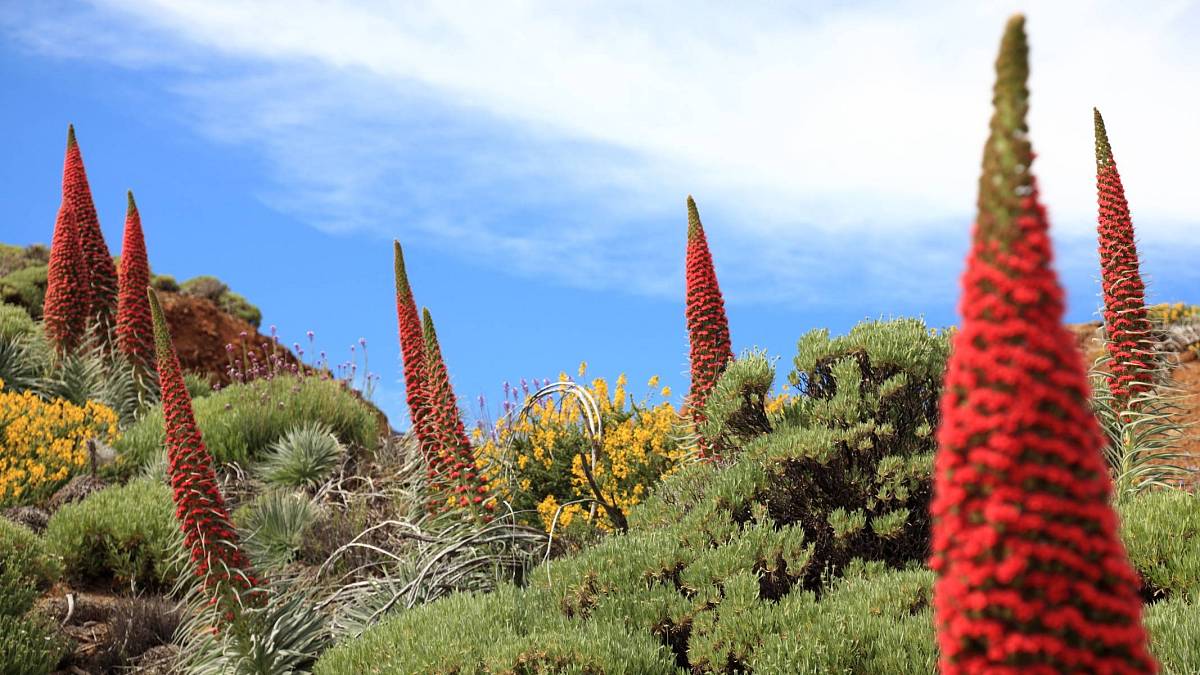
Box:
left=62, top=126, right=116, bottom=339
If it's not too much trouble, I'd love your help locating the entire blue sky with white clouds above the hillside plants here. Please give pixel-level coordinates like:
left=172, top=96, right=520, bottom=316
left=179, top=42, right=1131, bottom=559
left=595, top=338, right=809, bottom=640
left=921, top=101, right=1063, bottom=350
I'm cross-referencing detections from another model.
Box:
left=0, top=0, right=1200, bottom=425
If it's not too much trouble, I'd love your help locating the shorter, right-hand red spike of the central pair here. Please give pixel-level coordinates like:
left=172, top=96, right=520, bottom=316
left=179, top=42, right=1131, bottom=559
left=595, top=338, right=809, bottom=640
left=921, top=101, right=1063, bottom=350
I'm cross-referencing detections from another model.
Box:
left=421, top=309, right=494, bottom=510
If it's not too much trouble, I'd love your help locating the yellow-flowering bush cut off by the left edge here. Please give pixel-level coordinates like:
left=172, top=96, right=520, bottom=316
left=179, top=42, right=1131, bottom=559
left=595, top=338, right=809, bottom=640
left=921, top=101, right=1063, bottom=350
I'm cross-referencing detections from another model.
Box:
left=0, top=381, right=119, bottom=507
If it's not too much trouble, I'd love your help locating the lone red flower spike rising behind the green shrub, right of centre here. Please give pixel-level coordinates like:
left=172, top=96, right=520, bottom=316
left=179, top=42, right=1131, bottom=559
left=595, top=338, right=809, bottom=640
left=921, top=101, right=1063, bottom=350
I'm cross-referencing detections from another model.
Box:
left=688, top=195, right=733, bottom=456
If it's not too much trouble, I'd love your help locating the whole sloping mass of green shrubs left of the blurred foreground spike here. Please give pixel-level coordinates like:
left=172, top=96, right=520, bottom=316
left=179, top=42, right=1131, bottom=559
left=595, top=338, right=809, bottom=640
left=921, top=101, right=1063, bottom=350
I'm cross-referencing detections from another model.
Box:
left=317, top=319, right=948, bottom=674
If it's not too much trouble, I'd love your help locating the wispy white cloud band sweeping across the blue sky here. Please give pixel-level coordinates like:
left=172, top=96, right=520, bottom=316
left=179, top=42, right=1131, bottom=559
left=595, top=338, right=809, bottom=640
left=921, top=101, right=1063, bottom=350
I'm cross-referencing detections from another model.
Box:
left=7, top=0, right=1200, bottom=305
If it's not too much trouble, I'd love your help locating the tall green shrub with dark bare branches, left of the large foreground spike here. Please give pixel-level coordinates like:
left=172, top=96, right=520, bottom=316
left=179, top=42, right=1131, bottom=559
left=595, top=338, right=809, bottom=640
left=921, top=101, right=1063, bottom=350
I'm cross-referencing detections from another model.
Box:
left=702, top=318, right=949, bottom=589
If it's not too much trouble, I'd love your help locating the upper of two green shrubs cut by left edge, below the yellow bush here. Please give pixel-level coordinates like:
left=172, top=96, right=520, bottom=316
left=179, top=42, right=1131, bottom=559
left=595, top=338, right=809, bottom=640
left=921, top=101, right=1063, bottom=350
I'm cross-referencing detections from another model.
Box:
left=0, top=518, right=62, bottom=616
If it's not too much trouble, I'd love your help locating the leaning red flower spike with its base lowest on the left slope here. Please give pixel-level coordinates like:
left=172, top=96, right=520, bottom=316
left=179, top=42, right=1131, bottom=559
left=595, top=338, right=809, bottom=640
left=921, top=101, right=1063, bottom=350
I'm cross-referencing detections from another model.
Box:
left=146, top=288, right=265, bottom=621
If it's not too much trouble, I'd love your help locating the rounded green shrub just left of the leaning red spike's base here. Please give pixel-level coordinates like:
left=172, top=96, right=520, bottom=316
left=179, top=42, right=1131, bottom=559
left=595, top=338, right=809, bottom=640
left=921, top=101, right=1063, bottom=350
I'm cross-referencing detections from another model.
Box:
left=46, top=478, right=184, bottom=589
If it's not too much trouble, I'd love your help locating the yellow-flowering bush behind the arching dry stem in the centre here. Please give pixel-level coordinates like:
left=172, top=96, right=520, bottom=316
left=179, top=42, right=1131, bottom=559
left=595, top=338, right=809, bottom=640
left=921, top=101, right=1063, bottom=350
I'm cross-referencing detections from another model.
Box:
left=476, top=364, right=686, bottom=532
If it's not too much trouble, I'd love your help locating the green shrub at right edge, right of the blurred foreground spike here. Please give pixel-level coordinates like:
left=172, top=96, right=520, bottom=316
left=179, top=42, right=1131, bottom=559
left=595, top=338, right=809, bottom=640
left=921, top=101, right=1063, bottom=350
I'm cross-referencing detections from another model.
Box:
left=1120, top=490, right=1200, bottom=602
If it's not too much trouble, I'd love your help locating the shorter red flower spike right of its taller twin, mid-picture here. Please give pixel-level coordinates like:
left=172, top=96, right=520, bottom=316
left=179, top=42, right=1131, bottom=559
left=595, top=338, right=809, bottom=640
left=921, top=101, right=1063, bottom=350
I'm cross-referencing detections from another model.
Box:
left=421, top=309, right=486, bottom=514
